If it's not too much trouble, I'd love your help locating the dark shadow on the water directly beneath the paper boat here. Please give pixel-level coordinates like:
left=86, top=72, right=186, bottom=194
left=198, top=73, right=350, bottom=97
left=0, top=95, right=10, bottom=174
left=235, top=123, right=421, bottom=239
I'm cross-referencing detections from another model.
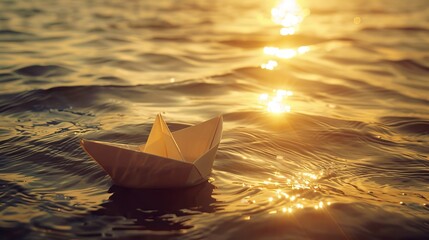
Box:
left=92, top=182, right=220, bottom=231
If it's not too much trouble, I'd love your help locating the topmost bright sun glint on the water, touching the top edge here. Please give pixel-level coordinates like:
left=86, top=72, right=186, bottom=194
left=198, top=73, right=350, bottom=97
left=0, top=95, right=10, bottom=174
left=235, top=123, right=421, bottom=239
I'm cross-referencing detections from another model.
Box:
left=271, top=0, right=310, bottom=35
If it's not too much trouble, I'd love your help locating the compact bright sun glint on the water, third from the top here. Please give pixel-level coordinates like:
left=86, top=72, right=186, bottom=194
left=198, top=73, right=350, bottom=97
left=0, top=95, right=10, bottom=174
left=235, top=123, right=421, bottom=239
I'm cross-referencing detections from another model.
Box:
left=259, top=89, right=293, bottom=114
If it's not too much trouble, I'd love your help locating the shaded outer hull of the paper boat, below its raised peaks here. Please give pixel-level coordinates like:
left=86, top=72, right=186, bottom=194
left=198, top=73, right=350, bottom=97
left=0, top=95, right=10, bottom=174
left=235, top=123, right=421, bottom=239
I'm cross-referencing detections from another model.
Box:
left=81, top=140, right=218, bottom=188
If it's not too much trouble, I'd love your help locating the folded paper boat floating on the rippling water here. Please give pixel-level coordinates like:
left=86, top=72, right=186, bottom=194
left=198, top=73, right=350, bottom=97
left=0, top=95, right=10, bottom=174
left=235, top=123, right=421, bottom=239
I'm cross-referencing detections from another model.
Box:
left=81, top=114, right=223, bottom=188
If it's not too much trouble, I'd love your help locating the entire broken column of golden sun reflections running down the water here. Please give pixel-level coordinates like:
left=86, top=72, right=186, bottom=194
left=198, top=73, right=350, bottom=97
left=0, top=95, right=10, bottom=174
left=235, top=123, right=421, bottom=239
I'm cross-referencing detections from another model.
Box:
left=236, top=0, right=331, bottom=220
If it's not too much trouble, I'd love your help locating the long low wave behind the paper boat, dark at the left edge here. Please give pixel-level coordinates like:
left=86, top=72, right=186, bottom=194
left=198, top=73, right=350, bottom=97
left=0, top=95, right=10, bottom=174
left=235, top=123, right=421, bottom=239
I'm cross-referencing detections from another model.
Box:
left=0, top=80, right=249, bottom=113
